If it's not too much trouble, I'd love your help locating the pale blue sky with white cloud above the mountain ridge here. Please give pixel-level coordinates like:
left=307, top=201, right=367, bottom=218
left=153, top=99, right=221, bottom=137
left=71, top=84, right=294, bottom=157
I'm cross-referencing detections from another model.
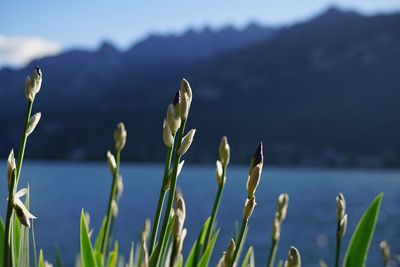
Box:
left=0, top=0, right=400, bottom=67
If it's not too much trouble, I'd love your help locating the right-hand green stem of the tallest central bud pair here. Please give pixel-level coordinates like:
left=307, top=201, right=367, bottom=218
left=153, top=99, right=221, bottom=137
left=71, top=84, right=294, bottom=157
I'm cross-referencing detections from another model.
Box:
left=151, top=120, right=186, bottom=267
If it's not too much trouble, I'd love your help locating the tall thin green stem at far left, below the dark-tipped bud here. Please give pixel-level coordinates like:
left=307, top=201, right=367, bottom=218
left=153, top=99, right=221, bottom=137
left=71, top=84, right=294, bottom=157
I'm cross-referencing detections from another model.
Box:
left=4, top=101, right=33, bottom=267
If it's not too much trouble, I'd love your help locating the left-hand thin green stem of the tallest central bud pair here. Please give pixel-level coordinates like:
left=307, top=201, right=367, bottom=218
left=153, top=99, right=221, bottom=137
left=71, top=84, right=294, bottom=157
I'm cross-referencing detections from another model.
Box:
left=150, top=147, right=172, bottom=254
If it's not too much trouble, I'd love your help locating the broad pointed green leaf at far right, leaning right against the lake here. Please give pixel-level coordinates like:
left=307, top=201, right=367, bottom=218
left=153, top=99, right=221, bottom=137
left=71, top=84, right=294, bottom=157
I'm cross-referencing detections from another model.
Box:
left=343, top=193, right=383, bottom=267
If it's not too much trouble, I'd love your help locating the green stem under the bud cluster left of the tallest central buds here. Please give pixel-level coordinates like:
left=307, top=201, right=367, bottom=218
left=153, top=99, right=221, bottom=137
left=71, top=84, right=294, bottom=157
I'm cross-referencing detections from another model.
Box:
left=100, top=150, right=121, bottom=257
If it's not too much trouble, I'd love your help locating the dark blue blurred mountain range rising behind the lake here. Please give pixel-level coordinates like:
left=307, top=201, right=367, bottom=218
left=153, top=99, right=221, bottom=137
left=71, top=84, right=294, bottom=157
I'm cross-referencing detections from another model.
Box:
left=0, top=8, right=400, bottom=167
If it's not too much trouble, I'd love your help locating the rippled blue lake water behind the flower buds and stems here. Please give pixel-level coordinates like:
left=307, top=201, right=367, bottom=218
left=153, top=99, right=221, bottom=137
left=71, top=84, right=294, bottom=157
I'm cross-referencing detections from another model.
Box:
left=0, top=162, right=400, bottom=266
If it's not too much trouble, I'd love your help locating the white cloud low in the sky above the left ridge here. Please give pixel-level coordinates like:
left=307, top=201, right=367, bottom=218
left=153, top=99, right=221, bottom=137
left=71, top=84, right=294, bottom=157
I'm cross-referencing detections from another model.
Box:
left=0, top=35, right=60, bottom=67
